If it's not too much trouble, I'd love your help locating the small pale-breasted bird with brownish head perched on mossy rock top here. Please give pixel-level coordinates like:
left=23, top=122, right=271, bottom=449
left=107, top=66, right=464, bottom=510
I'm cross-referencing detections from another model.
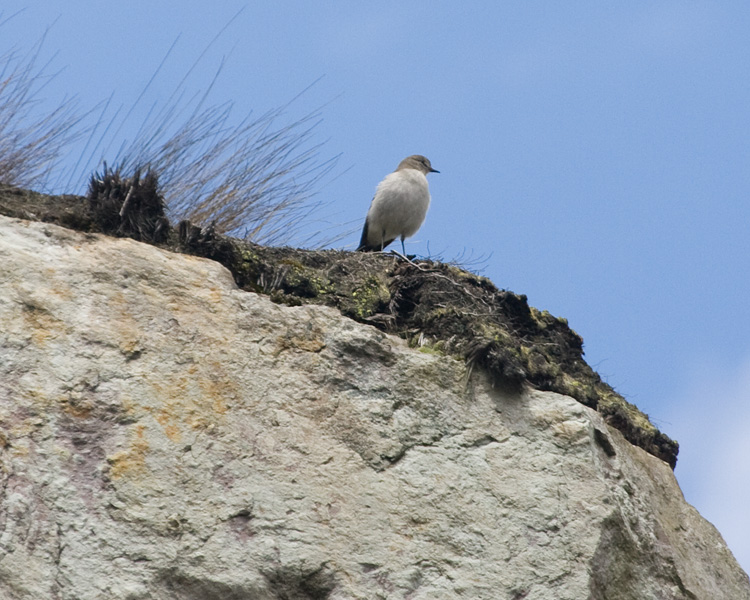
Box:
left=357, top=154, right=440, bottom=256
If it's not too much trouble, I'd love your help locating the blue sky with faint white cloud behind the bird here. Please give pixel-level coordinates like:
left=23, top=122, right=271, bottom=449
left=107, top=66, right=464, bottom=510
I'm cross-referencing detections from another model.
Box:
left=0, top=0, right=750, bottom=570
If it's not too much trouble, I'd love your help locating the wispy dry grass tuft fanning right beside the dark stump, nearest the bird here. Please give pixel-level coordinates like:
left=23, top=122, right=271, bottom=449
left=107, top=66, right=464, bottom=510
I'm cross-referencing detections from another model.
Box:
left=112, top=94, right=336, bottom=244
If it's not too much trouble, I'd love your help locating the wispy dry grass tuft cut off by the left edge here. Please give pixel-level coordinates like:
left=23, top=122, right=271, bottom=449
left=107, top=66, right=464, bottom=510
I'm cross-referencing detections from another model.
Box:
left=0, top=30, right=83, bottom=189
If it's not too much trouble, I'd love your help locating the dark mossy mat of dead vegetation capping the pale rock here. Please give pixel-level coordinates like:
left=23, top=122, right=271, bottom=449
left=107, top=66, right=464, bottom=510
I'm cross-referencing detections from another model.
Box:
left=0, top=184, right=678, bottom=467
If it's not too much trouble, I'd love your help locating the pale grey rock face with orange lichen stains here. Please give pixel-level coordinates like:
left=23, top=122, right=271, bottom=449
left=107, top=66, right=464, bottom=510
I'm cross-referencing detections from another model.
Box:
left=0, top=217, right=750, bottom=600
